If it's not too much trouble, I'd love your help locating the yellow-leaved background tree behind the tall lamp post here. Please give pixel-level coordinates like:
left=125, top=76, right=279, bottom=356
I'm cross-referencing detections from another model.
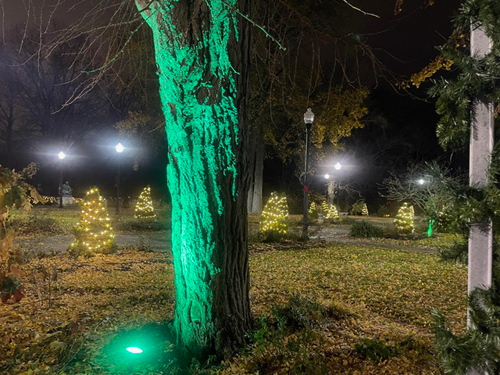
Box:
left=248, top=0, right=383, bottom=214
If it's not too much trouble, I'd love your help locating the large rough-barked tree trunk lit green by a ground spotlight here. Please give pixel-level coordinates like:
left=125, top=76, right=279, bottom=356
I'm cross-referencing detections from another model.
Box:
left=136, top=0, right=251, bottom=355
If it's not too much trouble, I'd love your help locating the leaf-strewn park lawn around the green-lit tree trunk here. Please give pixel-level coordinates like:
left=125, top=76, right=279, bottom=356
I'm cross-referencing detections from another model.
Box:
left=0, top=207, right=467, bottom=375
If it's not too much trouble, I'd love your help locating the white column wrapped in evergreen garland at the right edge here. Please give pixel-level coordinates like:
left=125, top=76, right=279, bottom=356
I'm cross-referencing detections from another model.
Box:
left=468, top=24, right=493, bottom=375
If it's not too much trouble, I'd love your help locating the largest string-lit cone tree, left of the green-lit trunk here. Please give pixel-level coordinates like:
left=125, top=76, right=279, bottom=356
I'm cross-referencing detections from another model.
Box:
left=70, top=188, right=115, bottom=255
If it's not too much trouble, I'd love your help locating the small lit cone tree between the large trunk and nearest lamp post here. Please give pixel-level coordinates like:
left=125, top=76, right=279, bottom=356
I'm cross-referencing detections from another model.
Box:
left=260, top=192, right=288, bottom=240
